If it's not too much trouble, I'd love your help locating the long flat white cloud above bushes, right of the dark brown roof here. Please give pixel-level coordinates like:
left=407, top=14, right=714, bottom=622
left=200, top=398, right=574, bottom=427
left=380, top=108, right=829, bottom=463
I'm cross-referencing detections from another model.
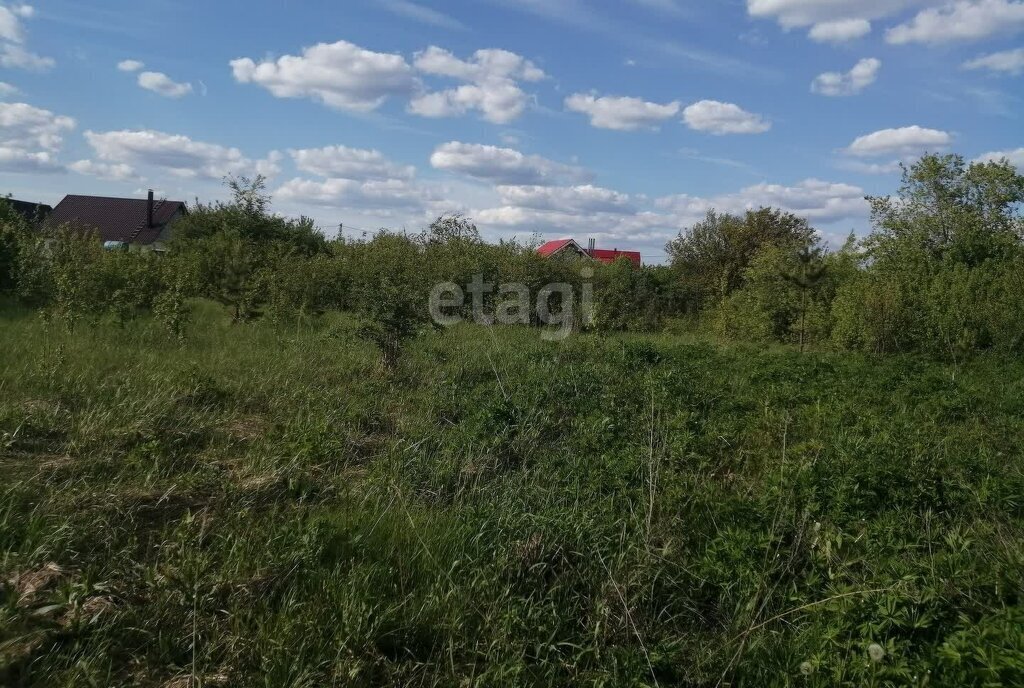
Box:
left=85, top=130, right=281, bottom=179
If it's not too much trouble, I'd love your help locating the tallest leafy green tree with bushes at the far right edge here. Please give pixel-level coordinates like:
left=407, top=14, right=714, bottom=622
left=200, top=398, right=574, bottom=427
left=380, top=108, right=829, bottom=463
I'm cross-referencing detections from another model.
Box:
left=834, top=156, right=1024, bottom=359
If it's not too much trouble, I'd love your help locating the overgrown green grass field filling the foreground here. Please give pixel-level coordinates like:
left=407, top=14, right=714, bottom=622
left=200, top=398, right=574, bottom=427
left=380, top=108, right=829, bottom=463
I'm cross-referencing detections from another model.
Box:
left=0, top=304, right=1024, bottom=688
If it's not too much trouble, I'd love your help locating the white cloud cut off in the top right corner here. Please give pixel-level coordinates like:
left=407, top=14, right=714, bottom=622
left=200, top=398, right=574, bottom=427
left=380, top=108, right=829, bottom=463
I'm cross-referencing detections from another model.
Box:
left=886, top=0, right=1024, bottom=45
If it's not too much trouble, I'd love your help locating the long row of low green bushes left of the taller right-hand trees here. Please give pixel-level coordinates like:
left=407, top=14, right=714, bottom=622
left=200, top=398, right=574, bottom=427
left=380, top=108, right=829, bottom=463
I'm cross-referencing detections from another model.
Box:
left=0, top=178, right=672, bottom=360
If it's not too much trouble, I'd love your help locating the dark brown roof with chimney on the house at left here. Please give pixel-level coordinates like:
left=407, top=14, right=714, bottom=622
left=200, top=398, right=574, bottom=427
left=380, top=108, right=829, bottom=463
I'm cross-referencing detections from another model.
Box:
left=46, top=196, right=186, bottom=244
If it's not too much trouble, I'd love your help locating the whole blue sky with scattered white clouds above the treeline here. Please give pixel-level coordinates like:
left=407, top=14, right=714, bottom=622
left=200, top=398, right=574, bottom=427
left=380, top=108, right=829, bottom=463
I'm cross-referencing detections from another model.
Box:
left=0, top=0, right=1024, bottom=262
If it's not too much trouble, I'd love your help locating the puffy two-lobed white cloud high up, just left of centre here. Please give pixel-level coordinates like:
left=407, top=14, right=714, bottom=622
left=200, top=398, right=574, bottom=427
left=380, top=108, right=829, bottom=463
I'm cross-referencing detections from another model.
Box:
left=409, top=45, right=545, bottom=124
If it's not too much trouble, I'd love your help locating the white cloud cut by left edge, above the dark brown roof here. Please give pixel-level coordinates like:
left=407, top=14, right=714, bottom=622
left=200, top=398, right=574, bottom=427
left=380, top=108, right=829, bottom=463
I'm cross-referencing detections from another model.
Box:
left=0, top=102, right=75, bottom=172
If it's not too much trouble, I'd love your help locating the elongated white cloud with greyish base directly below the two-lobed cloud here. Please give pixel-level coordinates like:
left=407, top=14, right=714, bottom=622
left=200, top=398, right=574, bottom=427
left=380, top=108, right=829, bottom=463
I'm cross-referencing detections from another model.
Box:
left=430, top=141, right=586, bottom=185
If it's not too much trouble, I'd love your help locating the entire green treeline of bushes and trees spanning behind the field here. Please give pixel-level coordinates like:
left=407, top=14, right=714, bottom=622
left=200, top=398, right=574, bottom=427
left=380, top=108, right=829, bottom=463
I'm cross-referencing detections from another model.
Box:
left=0, top=156, right=1024, bottom=360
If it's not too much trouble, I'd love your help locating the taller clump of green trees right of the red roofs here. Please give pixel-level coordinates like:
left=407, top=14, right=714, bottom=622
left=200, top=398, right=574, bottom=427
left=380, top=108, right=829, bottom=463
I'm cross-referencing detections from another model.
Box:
left=669, top=156, right=1024, bottom=358
